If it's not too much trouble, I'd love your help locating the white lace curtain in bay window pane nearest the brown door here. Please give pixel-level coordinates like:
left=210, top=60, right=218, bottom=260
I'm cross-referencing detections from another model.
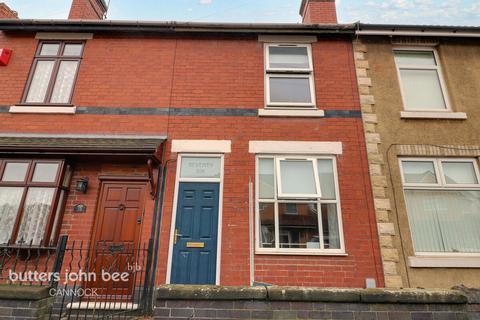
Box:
left=17, top=188, right=55, bottom=245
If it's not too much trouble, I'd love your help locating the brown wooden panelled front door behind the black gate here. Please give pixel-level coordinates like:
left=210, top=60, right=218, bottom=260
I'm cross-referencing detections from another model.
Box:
left=90, top=181, right=146, bottom=298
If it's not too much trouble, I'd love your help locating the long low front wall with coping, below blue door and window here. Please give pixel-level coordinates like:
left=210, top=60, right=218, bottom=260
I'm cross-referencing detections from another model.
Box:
left=154, top=285, right=480, bottom=320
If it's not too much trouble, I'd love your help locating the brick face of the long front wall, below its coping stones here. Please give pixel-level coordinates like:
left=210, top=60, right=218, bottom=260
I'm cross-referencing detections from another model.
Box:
left=154, top=300, right=472, bottom=320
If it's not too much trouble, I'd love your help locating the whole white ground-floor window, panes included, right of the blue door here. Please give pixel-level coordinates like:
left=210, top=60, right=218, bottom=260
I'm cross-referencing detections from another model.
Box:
left=256, top=155, right=345, bottom=255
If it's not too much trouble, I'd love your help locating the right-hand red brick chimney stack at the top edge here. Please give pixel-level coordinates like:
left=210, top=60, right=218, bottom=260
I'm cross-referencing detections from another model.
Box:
left=300, top=0, right=337, bottom=24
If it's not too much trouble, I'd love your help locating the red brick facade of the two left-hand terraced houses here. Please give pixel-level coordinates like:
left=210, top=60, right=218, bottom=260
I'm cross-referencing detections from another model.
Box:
left=0, top=34, right=383, bottom=287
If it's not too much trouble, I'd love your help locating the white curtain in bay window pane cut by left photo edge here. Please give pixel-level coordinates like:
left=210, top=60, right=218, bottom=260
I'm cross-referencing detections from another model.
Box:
left=0, top=187, right=23, bottom=243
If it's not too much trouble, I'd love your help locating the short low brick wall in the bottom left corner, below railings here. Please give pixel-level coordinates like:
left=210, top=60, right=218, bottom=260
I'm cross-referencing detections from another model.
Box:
left=0, top=285, right=54, bottom=320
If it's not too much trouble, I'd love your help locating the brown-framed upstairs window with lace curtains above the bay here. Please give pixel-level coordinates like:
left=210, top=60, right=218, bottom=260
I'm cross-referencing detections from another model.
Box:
left=22, top=41, right=84, bottom=105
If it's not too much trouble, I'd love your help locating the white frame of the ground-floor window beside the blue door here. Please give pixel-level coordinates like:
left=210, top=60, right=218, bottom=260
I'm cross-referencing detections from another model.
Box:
left=254, top=154, right=348, bottom=256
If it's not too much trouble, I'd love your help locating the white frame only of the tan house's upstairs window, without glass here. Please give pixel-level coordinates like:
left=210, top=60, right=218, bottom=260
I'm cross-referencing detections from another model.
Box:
left=392, top=47, right=453, bottom=113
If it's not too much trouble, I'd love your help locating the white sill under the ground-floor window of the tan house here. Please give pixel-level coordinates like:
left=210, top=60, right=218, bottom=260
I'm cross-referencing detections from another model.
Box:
left=408, top=254, right=480, bottom=268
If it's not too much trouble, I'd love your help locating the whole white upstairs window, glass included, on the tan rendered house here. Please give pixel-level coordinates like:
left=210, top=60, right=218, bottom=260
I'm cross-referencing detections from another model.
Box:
left=393, top=48, right=452, bottom=112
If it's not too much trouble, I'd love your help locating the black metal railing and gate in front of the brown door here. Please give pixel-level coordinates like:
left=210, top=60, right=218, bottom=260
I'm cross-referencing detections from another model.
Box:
left=0, top=236, right=153, bottom=319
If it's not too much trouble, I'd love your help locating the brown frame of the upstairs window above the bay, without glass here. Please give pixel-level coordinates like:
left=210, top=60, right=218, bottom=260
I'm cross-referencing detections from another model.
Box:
left=20, top=40, right=85, bottom=107
